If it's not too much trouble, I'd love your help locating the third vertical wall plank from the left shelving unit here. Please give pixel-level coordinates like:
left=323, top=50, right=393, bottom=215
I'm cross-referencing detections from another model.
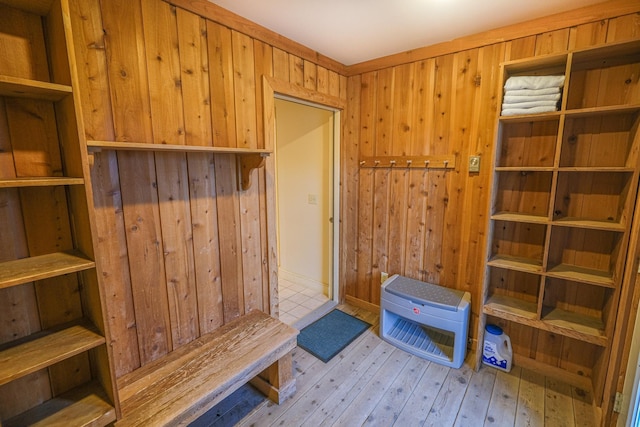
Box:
left=142, top=0, right=200, bottom=350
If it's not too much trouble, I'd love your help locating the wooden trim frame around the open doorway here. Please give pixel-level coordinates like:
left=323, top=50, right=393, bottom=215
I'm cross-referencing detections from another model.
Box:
left=262, top=76, right=347, bottom=316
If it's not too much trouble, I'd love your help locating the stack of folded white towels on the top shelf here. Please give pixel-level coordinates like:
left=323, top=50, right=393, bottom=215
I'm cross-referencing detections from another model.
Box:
left=502, top=76, right=564, bottom=116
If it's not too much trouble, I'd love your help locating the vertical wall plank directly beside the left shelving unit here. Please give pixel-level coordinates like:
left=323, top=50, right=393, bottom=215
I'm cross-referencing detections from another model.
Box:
left=70, top=0, right=140, bottom=377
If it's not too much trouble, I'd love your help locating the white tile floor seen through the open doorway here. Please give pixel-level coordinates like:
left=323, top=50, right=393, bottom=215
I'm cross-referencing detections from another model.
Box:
left=278, top=278, right=329, bottom=325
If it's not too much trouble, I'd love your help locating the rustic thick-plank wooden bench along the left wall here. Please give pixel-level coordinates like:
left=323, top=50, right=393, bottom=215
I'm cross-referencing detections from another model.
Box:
left=116, top=310, right=298, bottom=427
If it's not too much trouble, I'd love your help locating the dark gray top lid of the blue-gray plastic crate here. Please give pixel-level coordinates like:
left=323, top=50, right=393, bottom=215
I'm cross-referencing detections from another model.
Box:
left=386, top=276, right=464, bottom=311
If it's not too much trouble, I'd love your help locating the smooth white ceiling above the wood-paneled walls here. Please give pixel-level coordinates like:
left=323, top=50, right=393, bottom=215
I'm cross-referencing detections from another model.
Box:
left=210, top=0, right=603, bottom=65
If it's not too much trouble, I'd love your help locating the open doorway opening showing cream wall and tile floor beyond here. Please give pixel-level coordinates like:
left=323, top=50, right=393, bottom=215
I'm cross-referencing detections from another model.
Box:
left=274, top=96, right=339, bottom=329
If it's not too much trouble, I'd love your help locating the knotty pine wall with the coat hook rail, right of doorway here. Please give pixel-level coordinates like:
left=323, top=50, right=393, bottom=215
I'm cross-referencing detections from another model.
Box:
left=344, top=8, right=640, bottom=339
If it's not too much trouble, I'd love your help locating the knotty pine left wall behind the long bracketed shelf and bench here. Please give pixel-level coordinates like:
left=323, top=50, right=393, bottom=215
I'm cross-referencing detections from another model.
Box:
left=71, top=0, right=346, bottom=377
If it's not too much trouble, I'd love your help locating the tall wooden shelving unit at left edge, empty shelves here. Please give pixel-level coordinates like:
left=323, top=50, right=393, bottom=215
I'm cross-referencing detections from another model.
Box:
left=0, top=0, right=117, bottom=426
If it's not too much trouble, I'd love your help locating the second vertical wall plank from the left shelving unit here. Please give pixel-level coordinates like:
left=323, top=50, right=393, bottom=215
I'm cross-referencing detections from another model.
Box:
left=101, top=1, right=172, bottom=364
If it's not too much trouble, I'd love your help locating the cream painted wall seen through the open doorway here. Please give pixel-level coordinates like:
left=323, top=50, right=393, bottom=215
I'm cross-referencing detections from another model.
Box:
left=275, top=99, right=334, bottom=287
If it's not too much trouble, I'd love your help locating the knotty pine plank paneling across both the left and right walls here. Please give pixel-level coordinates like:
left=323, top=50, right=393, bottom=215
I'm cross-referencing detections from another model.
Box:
left=66, top=0, right=640, bottom=384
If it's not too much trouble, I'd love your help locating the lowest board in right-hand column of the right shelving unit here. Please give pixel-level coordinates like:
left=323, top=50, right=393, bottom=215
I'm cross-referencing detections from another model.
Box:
left=542, top=307, right=607, bottom=347
